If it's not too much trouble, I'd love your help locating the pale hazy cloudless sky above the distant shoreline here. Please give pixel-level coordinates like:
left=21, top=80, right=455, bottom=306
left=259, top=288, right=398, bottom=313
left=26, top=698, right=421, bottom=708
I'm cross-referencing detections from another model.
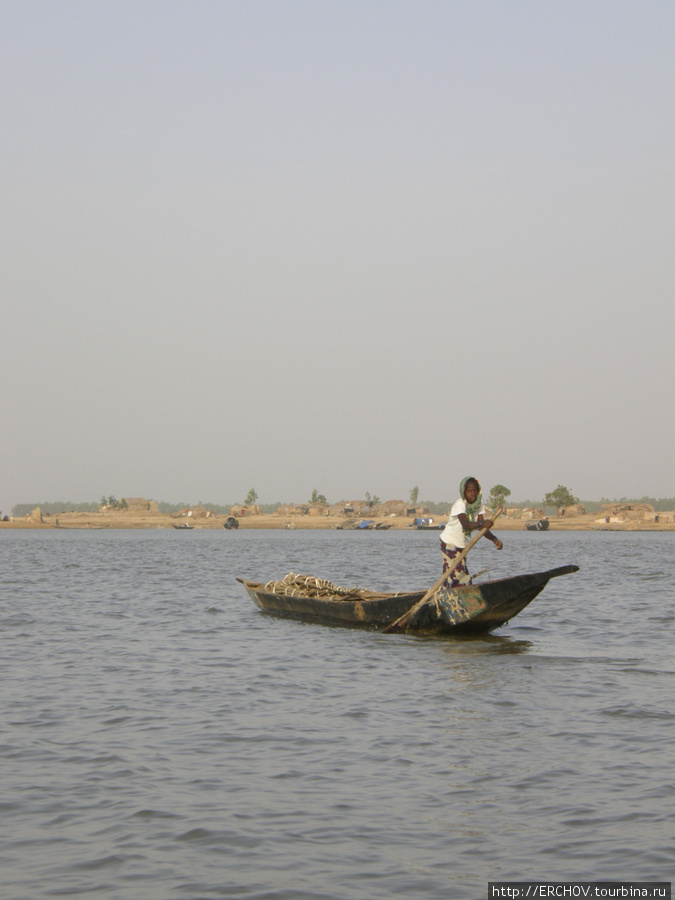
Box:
left=0, top=0, right=675, bottom=512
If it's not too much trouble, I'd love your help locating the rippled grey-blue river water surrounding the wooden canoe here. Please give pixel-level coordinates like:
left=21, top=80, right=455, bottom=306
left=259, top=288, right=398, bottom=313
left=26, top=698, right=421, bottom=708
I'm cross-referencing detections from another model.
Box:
left=0, top=529, right=675, bottom=900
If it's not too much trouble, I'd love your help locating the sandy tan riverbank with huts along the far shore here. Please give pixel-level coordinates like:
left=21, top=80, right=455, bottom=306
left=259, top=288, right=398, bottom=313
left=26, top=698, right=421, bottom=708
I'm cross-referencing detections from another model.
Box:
left=0, top=510, right=675, bottom=531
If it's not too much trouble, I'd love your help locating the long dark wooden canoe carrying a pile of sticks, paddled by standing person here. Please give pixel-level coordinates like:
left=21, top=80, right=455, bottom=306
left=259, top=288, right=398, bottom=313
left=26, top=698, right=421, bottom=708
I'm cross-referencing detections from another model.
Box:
left=237, top=566, right=579, bottom=634
